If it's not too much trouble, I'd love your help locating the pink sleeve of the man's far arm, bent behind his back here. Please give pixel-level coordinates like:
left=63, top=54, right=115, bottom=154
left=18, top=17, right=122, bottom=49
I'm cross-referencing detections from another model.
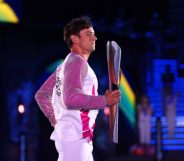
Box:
left=35, top=73, right=56, bottom=126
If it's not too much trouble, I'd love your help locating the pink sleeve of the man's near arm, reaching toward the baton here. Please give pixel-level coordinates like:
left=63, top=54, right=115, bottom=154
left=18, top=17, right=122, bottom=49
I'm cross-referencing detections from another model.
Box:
left=63, top=57, right=105, bottom=110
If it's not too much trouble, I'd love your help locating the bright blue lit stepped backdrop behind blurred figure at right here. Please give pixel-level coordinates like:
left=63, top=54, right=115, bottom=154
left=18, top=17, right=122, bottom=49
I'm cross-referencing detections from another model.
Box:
left=147, top=59, right=184, bottom=150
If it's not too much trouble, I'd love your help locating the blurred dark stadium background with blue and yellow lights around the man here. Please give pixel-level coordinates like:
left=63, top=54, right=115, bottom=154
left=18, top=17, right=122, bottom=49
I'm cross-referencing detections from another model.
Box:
left=0, top=0, right=184, bottom=161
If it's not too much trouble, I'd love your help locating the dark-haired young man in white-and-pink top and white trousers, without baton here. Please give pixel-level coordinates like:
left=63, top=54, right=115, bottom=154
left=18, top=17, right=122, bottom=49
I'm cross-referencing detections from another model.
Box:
left=35, top=17, right=121, bottom=161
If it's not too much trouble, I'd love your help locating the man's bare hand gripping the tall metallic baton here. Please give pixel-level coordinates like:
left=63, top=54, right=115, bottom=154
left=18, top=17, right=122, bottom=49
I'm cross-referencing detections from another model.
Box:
left=105, top=90, right=121, bottom=107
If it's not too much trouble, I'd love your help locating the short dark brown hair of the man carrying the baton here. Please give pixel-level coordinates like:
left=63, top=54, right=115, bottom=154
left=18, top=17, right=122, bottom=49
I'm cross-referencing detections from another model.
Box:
left=63, top=16, right=93, bottom=48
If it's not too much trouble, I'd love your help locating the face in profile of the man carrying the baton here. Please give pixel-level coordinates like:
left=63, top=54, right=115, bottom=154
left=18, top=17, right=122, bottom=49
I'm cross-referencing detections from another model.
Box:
left=78, top=27, right=97, bottom=53
